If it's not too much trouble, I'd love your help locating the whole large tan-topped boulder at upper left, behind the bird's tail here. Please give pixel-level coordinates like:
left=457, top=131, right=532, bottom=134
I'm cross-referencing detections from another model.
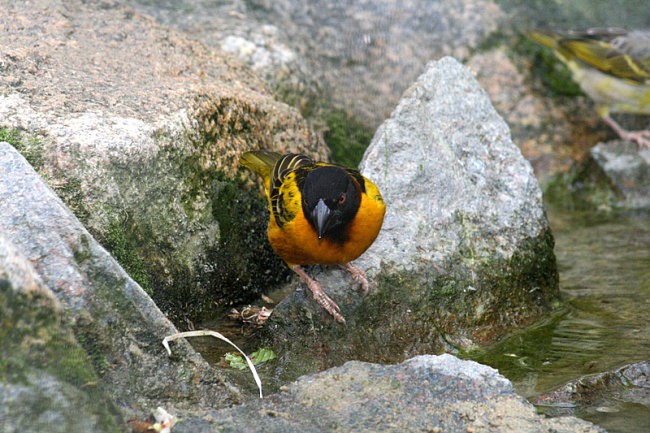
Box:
left=0, top=0, right=327, bottom=320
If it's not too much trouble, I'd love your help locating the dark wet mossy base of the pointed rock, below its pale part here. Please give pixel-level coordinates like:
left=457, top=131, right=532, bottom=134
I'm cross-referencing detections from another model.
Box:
left=261, top=230, right=559, bottom=383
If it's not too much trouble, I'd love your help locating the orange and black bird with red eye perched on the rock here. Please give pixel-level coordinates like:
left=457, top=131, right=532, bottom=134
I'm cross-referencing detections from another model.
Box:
left=239, top=150, right=386, bottom=324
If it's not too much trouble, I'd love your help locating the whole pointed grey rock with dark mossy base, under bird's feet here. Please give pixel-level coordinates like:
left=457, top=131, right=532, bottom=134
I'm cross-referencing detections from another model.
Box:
left=265, top=58, right=558, bottom=378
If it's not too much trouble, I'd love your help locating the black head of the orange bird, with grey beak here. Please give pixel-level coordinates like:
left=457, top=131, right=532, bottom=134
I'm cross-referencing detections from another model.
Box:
left=302, top=166, right=361, bottom=242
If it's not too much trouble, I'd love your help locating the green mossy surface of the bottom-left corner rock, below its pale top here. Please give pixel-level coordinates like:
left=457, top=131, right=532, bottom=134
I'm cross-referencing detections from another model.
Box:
left=0, top=277, right=122, bottom=431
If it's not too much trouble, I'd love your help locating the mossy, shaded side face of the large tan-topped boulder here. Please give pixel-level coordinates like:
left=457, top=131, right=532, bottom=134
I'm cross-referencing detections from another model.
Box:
left=0, top=90, right=325, bottom=328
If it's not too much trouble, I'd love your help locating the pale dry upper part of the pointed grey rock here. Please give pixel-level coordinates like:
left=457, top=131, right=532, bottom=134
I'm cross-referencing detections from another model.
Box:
left=360, top=57, right=556, bottom=274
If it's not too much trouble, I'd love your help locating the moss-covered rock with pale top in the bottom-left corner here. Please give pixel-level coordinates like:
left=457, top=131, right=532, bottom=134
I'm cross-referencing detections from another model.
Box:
left=0, top=235, right=126, bottom=433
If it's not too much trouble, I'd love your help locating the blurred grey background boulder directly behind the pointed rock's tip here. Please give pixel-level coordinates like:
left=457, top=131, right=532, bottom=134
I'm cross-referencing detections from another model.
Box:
left=129, top=0, right=506, bottom=129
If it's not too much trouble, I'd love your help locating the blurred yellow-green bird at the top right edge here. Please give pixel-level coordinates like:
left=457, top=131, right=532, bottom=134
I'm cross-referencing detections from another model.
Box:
left=527, top=28, right=650, bottom=147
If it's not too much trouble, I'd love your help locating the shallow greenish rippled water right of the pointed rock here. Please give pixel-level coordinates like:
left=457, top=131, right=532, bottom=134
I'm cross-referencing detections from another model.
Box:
left=475, top=210, right=650, bottom=433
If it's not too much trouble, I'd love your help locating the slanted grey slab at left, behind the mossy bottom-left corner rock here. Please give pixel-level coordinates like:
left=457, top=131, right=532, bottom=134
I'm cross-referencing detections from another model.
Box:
left=0, top=143, right=239, bottom=419
